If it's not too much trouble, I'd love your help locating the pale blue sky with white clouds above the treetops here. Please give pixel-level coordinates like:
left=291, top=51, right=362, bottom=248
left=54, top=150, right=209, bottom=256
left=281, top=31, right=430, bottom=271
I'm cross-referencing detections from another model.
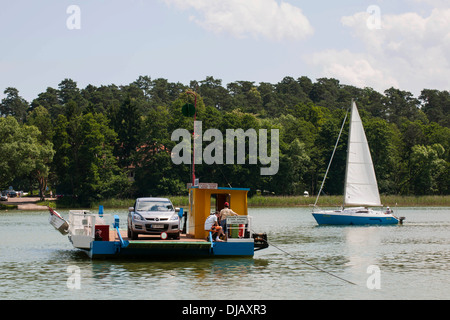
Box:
left=0, top=0, right=450, bottom=101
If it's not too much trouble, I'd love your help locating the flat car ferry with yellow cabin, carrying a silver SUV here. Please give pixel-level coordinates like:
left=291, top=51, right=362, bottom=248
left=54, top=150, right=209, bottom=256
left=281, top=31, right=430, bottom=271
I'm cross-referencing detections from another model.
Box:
left=49, top=183, right=268, bottom=259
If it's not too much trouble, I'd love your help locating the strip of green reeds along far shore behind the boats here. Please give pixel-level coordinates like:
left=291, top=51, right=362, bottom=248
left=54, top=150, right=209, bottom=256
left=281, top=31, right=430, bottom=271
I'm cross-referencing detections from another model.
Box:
left=84, top=195, right=450, bottom=209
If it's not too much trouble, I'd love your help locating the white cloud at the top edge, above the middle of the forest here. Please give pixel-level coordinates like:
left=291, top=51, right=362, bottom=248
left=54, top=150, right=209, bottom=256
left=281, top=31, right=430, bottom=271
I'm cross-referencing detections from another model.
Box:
left=164, top=0, right=314, bottom=40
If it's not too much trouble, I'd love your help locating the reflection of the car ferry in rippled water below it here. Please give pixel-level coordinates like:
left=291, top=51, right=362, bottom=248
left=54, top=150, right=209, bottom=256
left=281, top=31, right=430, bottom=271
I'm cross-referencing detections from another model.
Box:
left=43, top=258, right=267, bottom=299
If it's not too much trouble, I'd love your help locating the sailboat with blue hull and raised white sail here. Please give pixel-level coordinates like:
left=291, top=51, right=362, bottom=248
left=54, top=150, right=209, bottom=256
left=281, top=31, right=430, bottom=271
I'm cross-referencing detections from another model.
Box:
left=312, top=100, right=404, bottom=225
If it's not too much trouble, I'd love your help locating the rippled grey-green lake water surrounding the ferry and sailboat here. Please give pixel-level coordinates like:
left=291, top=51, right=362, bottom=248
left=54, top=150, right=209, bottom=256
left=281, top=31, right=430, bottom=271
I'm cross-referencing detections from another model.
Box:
left=0, top=208, right=450, bottom=300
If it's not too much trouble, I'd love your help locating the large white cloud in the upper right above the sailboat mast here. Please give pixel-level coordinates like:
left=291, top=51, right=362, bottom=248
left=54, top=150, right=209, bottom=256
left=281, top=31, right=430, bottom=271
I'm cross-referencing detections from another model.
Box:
left=311, top=9, right=450, bottom=95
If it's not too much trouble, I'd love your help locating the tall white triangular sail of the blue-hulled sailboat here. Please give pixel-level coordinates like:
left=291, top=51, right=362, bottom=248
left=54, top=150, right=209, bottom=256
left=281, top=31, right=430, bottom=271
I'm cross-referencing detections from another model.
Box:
left=344, top=101, right=382, bottom=206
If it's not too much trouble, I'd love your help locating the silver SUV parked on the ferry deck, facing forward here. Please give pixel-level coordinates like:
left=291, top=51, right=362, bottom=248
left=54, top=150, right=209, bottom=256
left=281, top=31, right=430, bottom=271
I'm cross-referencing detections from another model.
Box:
left=128, top=198, right=180, bottom=240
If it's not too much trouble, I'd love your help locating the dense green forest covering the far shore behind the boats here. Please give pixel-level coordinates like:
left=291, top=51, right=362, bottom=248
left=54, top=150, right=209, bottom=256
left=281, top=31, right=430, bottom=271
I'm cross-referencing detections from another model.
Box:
left=0, top=76, right=450, bottom=203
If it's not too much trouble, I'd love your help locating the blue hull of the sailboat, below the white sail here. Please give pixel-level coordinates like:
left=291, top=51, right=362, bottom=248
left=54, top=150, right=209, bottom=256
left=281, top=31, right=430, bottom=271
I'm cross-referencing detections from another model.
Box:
left=312, top=212, right=399, bottom=225
